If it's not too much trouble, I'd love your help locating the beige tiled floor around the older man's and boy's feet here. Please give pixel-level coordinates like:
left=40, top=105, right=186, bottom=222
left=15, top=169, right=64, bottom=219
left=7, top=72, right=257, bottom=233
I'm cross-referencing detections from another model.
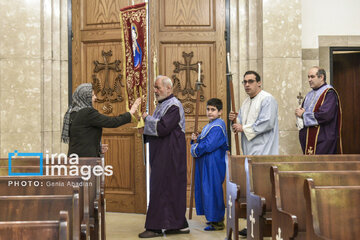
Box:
left=106, top=212, right=236, bottom=240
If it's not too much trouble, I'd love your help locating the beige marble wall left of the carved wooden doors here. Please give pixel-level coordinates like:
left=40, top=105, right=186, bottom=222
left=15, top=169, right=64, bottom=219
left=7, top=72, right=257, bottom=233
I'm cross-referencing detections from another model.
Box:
left=0, top=0, right=68, bottom=157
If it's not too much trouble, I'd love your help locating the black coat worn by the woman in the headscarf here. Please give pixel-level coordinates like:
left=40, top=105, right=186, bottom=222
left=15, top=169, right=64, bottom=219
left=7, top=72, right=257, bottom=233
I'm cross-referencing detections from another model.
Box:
left=68, top=108, right=131, bottom=157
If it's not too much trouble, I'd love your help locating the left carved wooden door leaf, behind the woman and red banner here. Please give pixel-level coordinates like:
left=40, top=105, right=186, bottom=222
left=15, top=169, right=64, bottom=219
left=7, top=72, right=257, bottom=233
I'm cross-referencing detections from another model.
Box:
left=72, top=0, right=146, bottom=213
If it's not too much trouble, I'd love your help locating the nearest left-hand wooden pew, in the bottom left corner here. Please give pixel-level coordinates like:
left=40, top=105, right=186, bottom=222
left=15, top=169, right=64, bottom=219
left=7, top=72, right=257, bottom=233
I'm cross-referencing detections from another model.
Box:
left=0, top=211, right=70, bottom=240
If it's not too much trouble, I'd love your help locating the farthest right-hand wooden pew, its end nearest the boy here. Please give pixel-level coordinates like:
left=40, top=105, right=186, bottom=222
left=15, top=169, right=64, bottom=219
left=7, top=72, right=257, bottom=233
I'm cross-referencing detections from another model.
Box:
left=226, top=152, right=360, bottom=240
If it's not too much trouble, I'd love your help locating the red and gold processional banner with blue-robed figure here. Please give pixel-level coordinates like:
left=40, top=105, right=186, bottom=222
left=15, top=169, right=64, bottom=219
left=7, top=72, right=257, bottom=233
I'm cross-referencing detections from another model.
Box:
left=120, top=3, right=148, bottom=127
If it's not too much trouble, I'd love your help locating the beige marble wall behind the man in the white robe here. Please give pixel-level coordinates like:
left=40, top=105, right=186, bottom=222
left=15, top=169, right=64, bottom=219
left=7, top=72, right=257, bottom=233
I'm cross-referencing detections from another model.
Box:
left=230, top=0, right=303, bottom=154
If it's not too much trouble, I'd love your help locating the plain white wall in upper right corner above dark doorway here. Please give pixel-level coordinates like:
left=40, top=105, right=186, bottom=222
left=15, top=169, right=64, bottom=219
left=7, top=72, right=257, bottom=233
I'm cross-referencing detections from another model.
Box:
left=302, top=0, right=360, bottom=48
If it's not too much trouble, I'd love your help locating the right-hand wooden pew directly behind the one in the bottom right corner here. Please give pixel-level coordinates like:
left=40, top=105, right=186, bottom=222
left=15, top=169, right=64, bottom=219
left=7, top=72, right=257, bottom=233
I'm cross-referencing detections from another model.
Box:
left=270, top=166, right=360, bottom=240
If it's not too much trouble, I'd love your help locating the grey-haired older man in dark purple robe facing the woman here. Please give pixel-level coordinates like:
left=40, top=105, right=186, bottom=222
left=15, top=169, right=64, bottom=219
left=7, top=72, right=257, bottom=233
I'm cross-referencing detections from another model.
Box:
left=139, top=76, right=189, bottom=238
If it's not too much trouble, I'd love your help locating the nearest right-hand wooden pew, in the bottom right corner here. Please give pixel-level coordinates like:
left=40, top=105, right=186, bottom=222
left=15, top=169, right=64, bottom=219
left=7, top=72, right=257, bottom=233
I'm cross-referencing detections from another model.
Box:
left=304, top=179, right=360, bottom=240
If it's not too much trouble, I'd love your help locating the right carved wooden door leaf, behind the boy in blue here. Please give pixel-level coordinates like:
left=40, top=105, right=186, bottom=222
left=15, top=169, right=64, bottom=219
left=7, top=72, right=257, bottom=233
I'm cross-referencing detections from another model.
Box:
left=149, top=0, right=227, bottom=206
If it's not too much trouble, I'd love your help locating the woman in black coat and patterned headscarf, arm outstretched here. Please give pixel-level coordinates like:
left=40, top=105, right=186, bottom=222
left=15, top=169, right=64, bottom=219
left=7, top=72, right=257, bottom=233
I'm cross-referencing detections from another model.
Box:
left=61, top=83, right=141, bottom=157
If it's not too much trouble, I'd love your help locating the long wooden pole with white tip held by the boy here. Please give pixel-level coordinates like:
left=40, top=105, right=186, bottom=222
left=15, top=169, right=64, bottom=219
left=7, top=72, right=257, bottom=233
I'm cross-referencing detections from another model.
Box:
left=189, top=63, right=203, bottom=219
